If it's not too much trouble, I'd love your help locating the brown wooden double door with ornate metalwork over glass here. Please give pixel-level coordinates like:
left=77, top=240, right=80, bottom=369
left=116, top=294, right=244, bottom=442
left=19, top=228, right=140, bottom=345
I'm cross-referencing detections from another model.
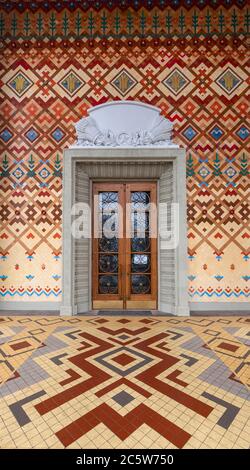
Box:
left=92, top=182, right=157, bottom=309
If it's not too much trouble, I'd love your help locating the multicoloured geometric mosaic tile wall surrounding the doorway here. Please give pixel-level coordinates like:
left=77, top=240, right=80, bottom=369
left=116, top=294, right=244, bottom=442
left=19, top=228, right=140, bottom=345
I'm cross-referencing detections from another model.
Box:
left=0, top=0, right=250, bottom=301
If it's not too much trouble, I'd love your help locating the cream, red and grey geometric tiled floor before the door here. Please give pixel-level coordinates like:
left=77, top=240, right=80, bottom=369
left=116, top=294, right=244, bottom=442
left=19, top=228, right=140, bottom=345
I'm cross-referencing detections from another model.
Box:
left=0, top=316, right=250, bottom=449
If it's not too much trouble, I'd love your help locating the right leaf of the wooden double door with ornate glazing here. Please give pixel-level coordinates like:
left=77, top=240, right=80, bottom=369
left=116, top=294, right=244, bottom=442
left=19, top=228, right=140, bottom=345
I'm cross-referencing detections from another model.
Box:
left=126, top=183, right=157, bottom=308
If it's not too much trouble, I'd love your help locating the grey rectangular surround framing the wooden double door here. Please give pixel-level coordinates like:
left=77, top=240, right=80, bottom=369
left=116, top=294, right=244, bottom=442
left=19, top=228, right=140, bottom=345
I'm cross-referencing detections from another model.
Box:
left=60, top=147, right=189, bottom=315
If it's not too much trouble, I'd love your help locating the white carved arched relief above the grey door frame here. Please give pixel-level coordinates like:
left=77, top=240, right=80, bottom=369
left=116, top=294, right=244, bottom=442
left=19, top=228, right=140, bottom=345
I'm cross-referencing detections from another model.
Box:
left=75, top=101, right=175, bottom=147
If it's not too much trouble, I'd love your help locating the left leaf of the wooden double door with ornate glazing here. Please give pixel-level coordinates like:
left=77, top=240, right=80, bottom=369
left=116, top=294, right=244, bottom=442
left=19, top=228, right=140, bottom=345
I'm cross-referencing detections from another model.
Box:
left=92, top=183, right=124, bottom=309
